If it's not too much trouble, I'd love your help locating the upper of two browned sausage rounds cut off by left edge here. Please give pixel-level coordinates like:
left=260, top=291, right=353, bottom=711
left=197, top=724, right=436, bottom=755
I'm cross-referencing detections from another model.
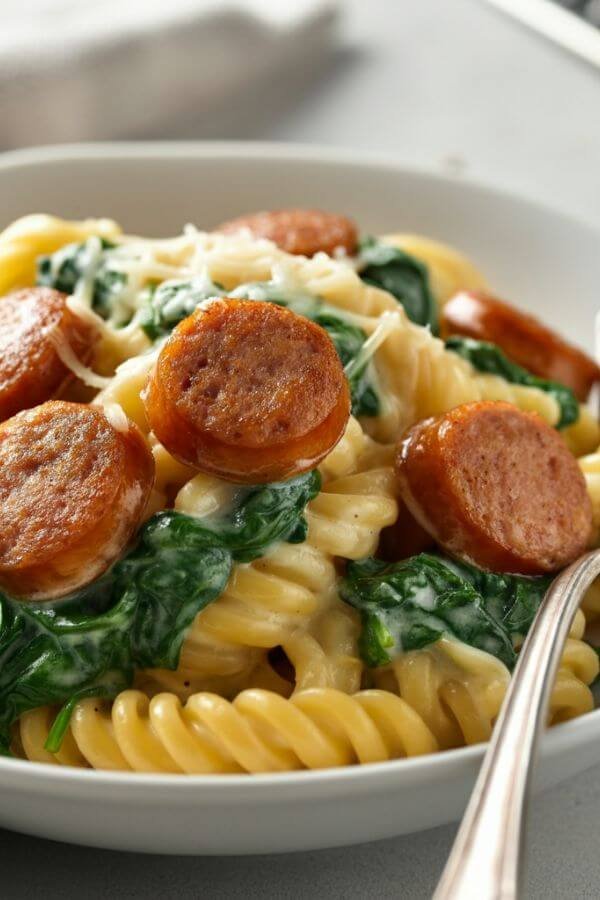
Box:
left=0, top=287, right=97, bottom=421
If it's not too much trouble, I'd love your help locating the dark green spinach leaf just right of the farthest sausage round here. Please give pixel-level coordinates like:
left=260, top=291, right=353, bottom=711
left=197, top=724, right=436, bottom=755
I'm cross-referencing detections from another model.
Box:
left=359, top=237, right=439, bottom=334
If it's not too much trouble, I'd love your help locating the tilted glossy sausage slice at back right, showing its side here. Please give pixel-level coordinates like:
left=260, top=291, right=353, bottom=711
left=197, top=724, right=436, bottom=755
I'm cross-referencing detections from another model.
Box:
left=441, top=291, right=600, bottom=400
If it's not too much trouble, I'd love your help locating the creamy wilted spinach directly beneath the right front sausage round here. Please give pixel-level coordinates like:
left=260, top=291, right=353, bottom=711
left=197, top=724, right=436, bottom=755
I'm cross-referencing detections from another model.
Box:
left=340, top=553, right=550, bottom=668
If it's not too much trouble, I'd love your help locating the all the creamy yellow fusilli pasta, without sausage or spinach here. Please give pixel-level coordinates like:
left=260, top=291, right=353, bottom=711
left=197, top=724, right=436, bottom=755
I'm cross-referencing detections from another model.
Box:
left=5, top=216, right=600, bottom=773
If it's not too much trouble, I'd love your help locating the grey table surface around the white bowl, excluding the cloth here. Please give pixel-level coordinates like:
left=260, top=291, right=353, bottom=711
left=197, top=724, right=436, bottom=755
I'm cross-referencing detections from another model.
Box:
left=0, top=0, right=600, bottom=900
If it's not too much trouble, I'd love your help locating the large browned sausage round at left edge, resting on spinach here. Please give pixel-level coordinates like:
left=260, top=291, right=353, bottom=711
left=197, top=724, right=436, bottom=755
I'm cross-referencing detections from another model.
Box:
left=0, top=400, right=154, bottom=600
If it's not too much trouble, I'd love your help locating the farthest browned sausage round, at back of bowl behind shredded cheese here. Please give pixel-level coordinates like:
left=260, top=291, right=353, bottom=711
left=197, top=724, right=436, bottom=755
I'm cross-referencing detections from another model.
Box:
left=215, top=209, right=358, bottom=256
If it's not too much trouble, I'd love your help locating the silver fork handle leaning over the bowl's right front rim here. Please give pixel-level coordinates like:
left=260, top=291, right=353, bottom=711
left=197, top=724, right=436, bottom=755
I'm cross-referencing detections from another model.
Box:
left=433, top=550, right=600, bottom=900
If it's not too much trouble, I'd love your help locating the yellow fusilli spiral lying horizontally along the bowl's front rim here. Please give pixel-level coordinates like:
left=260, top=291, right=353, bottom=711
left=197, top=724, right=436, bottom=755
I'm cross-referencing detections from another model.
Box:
left=20, top=688, right=437, bottom=774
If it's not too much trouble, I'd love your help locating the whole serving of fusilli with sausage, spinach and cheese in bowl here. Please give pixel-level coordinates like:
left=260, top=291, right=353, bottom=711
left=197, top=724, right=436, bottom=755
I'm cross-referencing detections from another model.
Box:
left=0, top=210, right=600, bottom=774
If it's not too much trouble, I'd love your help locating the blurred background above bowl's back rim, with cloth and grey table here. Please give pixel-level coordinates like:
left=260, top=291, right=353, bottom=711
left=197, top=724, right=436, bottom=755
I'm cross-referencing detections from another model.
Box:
left=0, top=0, right=600, bottom=223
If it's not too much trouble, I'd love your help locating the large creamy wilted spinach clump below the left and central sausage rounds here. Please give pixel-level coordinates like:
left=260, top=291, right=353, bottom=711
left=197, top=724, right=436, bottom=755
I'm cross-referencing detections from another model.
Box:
left=0, top=472, right=320, bottom=752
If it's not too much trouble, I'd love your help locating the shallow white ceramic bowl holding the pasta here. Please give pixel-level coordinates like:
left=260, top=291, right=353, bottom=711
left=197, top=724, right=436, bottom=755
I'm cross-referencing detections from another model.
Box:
left=0, top=144, right=600, bottom=854
